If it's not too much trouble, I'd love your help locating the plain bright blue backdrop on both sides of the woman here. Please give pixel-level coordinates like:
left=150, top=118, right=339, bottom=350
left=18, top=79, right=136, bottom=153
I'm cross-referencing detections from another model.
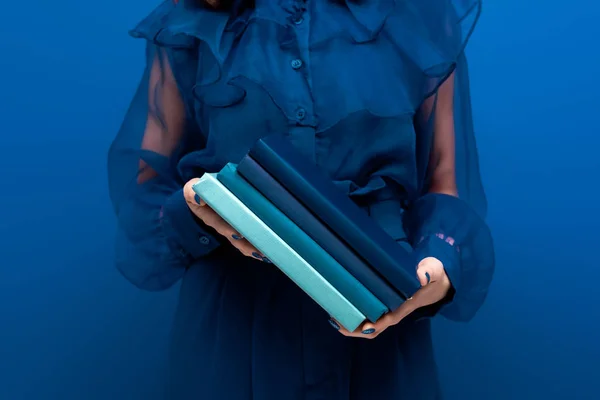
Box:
left=0, top=0, right=600, bottom=400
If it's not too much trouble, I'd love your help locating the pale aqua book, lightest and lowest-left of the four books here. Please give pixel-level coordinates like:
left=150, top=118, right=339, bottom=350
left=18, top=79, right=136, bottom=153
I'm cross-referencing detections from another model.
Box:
left=193, top=173, right=366, bottom=331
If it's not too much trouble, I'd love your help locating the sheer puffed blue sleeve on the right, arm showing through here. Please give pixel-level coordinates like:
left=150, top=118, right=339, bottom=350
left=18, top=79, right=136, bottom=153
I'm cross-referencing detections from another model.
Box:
left=406, top=54, right=495, bottom=321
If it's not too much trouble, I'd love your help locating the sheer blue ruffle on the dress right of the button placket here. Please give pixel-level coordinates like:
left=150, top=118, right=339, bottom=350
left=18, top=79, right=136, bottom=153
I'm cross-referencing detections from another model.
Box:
left=312, top=0, right=481, bottom=130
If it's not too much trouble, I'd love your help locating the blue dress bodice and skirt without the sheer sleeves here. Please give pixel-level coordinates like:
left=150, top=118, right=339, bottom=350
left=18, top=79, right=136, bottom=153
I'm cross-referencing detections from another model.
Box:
left=134, top=0, right=460, bottom=400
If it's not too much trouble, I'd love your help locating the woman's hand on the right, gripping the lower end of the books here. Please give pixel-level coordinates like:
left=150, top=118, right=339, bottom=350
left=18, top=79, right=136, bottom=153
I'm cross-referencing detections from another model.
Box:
left=331, top=257, right=451, bottom=339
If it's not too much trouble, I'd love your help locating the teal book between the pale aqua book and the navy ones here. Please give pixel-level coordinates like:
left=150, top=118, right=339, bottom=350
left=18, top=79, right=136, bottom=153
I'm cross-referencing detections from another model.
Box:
left=217, top=163, right=388, bottom=322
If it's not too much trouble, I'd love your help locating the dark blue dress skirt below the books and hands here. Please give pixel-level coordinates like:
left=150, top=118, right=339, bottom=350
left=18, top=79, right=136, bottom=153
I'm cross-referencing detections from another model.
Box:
left=167, top=246, right=441, bottom=400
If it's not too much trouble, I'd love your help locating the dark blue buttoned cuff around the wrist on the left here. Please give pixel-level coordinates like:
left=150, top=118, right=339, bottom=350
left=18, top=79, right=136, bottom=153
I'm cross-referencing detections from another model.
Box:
left=161, top=190, right=220, bottom=260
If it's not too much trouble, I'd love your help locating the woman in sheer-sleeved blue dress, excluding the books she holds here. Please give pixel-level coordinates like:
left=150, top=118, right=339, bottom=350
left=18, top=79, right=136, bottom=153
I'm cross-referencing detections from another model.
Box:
left=109, top=0, right=494, bottom=400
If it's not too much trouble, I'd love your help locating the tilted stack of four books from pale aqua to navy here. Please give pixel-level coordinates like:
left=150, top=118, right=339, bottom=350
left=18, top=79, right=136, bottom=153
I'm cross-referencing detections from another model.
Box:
left=193, top=136, right=419, bottom=331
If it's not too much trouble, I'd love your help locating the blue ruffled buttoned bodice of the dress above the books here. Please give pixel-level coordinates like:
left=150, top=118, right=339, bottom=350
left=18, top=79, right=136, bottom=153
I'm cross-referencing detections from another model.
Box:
left=156, top=0, right=436, bottom=222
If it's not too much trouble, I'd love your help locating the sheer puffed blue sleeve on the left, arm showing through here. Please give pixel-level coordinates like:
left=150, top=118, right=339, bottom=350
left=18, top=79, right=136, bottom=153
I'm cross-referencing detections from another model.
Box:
left=108, top=42, right=219, bottom=290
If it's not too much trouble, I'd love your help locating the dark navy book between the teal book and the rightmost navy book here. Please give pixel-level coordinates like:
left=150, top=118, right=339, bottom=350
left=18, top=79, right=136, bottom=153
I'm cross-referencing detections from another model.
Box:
left=237, top=156, right=404, bottom=310
